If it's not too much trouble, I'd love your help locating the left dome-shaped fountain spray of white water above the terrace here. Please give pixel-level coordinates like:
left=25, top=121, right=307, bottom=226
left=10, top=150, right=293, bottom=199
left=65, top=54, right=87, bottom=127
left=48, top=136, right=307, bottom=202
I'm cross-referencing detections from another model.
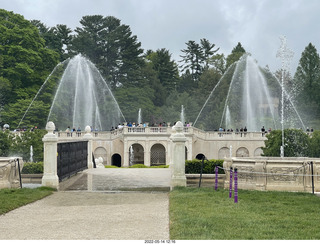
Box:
left=19, top=54, right=126, bottom=131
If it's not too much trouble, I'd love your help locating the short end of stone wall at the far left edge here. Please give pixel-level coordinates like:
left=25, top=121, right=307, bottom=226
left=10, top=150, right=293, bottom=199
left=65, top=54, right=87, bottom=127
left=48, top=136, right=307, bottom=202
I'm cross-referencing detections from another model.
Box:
left=0, top=157, right=23, bottom=189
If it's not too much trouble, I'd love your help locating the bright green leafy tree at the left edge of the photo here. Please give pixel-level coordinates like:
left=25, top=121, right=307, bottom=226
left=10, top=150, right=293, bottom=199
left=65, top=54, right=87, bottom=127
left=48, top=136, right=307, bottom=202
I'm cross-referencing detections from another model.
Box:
left=0, top=9, right=59, bottom=128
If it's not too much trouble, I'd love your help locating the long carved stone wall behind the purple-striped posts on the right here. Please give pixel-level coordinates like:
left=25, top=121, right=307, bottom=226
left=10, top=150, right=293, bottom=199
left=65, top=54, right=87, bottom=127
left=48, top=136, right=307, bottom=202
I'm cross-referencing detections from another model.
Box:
left=223, top=157, right=320, bottom=192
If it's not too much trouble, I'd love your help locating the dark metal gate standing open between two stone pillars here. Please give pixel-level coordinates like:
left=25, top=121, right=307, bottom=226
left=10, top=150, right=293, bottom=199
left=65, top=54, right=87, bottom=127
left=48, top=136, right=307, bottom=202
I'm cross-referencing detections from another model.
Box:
left=57, top=141, right=88, bottom=181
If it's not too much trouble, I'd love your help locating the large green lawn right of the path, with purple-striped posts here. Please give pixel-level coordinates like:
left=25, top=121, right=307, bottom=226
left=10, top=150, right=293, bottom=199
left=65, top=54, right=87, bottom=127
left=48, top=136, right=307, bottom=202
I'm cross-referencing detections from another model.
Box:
left=170, top=188, right=320, bottom=240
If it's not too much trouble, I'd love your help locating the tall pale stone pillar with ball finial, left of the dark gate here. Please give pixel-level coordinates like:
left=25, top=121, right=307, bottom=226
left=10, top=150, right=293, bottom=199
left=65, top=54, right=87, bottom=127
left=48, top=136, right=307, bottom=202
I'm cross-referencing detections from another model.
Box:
left=42, top=121, right=59, bottom=190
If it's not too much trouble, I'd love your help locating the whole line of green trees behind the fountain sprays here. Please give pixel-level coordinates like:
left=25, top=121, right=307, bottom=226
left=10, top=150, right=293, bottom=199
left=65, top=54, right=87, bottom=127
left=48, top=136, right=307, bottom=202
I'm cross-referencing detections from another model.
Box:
left=0, top=9, right=320, bottom=132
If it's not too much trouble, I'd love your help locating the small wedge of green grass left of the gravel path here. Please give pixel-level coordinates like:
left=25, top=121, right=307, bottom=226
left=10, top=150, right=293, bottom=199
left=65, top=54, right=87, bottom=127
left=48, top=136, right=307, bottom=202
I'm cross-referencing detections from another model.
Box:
left=0, top=187, right=54, bottom=215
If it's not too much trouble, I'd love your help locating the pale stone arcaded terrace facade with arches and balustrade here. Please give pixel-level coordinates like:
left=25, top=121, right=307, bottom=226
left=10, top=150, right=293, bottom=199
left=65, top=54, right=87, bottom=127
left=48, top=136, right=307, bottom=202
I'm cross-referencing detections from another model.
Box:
left=56, top=127, right=266, bottom=167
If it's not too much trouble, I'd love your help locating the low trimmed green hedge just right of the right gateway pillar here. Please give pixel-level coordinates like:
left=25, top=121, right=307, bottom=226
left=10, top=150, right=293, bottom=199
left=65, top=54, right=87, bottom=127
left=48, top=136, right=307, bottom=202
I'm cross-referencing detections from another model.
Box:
left=186, top=159, right=224, bottom=174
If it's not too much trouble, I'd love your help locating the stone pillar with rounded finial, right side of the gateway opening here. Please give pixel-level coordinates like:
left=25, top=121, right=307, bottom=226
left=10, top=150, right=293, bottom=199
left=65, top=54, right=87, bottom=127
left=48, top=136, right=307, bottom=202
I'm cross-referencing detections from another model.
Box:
left=170, top=121, right=187, bottom=189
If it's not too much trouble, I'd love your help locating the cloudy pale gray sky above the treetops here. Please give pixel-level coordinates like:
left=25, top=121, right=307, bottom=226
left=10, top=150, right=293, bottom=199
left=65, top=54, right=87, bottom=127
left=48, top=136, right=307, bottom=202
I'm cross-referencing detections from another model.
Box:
left=0, top=0, right=320, bottom=73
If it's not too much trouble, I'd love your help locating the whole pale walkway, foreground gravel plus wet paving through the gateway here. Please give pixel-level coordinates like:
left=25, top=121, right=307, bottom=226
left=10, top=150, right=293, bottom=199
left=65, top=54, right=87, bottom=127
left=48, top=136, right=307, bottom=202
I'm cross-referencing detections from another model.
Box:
left=0, top=169, right=170, bottom=240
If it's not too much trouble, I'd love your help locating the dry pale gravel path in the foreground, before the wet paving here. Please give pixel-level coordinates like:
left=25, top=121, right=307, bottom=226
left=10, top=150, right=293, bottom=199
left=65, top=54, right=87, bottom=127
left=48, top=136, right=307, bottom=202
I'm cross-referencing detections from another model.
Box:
left=0, top=191, right=169, bottom=240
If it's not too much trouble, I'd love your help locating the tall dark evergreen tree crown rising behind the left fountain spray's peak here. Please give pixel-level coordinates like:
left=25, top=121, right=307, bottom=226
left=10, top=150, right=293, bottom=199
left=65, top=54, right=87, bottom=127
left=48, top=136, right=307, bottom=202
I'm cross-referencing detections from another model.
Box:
left=72, top=15, right=144, bottom=88
